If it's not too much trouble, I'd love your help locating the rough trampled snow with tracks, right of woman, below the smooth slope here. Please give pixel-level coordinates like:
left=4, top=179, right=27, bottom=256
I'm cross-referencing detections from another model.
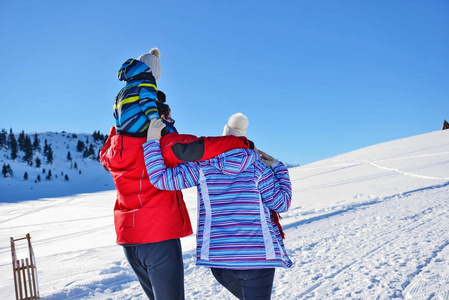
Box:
left=274, top=184, right=449, bottom=299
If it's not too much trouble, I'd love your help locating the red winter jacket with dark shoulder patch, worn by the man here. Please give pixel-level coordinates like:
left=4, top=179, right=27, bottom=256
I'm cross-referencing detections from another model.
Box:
left=100, top=127, right=253, bottom=244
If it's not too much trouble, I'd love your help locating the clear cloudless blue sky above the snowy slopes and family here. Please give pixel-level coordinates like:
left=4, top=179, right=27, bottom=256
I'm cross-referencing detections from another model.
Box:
left=0, top=0, right=449, bottom=164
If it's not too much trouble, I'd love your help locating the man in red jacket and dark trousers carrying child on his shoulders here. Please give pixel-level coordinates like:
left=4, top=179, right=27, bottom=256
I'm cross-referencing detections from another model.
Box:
left=100, top=103, right=254, bottom=300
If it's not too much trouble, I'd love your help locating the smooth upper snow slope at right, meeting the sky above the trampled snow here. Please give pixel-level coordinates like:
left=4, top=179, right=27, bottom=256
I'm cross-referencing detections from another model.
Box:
left=290, top=130, right=449, bottom=210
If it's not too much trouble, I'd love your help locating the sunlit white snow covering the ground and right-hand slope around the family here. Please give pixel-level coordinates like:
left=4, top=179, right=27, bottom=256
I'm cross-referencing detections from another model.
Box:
left=0, top=130, right=449, bottom=299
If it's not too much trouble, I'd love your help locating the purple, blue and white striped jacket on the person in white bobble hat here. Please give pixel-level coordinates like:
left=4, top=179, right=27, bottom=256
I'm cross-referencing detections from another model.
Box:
left=143, top=140, right=292, bottom=269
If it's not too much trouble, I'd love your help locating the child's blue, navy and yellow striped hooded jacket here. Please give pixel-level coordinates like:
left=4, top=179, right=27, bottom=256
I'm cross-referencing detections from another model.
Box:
left=113, top=59, right=159, bottom=137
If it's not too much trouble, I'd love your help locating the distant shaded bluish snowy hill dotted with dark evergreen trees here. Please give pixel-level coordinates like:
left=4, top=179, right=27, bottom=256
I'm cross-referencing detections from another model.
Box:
left=0, top=132, right=114, bottom=202
